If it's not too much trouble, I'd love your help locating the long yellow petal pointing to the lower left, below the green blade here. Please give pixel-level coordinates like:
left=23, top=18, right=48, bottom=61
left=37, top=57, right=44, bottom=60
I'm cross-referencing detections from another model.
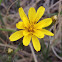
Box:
left=9, top=30, right=23, bottom=41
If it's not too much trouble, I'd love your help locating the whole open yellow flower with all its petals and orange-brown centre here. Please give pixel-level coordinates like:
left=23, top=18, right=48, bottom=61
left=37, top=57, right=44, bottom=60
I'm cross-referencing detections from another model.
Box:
left=9, top=6, right=54, bottom=51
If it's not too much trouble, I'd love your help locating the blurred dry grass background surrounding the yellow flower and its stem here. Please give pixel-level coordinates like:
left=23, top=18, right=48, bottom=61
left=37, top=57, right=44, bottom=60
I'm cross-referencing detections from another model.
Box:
left=0, top=0, right=62, bottom=62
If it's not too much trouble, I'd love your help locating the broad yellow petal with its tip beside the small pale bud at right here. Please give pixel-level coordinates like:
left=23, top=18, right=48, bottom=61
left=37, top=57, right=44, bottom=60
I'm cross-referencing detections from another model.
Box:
left=35, top=18, right=52, bottom=29
